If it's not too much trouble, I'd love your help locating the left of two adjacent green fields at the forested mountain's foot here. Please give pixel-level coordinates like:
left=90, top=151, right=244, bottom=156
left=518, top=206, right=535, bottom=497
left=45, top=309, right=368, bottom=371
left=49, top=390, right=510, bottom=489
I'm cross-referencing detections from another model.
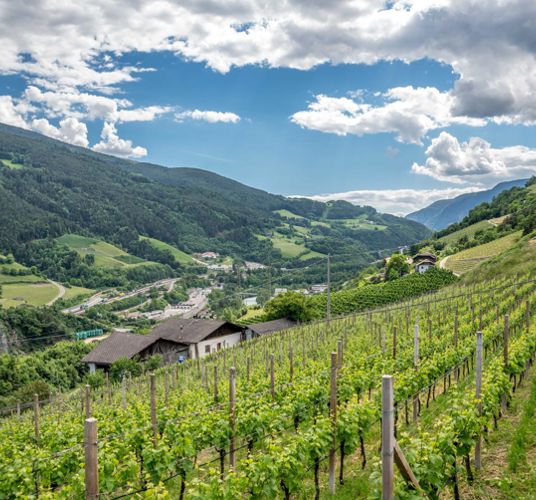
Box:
left=56, top=234, right=152, bottom=267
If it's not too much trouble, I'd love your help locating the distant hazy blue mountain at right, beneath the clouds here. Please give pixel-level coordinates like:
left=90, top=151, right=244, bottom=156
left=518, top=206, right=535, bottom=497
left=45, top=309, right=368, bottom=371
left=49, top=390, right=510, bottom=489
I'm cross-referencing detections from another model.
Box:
left=406, top=179, right=528, bottom=231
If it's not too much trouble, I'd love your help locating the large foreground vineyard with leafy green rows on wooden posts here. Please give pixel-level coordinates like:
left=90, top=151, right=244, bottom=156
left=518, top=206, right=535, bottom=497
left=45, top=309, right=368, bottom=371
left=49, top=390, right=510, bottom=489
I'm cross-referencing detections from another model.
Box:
left=0, top=275, right=536, bottom=499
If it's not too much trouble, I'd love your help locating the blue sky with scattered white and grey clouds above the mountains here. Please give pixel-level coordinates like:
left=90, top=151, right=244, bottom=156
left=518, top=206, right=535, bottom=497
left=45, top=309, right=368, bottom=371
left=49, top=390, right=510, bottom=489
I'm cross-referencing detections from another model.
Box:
left=0, top=0, right=536, bottom=214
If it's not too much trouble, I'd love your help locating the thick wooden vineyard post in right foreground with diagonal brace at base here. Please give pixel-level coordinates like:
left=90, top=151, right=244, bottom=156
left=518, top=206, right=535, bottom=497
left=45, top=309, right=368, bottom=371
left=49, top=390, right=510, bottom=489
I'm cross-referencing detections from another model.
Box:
left=382, top=375, right=395, bottom=500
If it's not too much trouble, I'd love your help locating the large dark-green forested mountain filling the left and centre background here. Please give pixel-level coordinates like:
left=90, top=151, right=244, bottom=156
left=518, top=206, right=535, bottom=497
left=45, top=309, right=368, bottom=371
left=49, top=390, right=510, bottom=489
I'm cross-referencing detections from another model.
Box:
left=0, top=125, right=430, bottom=284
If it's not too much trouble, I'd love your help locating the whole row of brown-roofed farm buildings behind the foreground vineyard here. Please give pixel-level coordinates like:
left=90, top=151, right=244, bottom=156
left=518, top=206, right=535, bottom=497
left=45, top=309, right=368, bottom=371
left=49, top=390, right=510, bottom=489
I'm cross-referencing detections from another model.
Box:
left=82, top=318, right=295, bottom=372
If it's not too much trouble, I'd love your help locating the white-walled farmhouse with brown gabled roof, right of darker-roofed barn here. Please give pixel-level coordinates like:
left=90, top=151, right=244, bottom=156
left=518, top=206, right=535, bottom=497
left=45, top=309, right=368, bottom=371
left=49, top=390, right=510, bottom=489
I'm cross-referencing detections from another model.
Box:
left=149, top=318, right=244, bottom=359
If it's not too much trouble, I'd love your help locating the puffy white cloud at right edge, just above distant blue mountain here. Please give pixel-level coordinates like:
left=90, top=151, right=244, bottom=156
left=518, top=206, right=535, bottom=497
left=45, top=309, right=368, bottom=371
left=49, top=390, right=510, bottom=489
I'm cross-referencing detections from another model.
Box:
left=411, top=132, right=536, bottom=184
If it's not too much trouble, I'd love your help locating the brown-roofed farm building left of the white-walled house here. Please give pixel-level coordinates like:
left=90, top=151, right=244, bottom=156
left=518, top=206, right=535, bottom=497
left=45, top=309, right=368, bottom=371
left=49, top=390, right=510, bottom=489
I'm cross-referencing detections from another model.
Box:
left=82, top=332, right=180, bottom=373
